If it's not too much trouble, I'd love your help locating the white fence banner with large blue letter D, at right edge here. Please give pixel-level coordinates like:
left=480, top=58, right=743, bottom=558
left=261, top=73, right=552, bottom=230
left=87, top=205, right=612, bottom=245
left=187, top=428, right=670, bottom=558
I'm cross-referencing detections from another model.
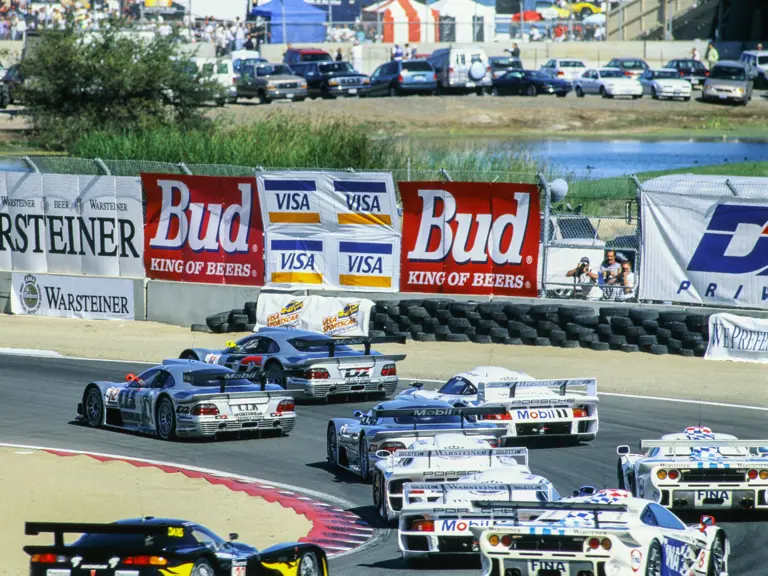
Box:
left=640, top=177, right=768, bottom=308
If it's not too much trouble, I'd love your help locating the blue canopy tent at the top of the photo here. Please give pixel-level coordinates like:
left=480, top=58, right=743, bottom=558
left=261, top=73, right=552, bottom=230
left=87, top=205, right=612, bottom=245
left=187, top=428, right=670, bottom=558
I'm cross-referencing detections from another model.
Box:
left=251, top=0, right=328, bottom=44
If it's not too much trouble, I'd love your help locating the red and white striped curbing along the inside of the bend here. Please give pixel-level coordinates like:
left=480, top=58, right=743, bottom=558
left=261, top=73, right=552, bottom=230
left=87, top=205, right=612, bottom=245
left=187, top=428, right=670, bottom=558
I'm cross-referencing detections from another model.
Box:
left=0, top=443, right=374, bottom=558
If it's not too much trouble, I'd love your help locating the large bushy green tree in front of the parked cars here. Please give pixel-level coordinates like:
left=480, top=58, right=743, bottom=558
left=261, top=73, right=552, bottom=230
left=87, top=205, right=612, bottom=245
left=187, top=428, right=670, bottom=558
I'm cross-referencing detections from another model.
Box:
left=21, top=26, right=222, bottom=148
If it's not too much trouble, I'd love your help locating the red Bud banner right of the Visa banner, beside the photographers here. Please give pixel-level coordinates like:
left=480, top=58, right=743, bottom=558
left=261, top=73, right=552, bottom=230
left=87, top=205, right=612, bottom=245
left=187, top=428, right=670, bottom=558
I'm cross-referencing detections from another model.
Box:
left=399, top=182, right=540, bottom=297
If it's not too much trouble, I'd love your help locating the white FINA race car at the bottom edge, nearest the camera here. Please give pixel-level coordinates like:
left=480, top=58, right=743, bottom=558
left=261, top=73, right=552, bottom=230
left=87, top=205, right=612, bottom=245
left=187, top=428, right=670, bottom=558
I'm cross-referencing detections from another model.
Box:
left=472, top=490, right=730, bottom=576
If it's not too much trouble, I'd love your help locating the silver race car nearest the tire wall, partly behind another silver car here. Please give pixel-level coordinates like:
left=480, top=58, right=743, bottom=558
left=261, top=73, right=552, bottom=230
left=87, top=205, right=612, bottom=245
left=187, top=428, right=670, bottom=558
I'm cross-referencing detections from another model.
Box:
left=180, top=328, right=405, bottom=399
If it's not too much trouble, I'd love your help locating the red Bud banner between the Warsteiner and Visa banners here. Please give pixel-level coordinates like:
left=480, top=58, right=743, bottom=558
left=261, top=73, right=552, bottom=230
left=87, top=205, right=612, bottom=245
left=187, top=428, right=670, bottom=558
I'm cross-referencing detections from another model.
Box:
left=141, top=174, right=264, bottom=286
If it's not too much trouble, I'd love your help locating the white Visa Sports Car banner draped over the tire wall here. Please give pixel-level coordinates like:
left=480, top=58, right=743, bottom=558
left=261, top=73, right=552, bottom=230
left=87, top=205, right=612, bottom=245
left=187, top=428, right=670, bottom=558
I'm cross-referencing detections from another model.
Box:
left=254, top=292, right=373, bottom=336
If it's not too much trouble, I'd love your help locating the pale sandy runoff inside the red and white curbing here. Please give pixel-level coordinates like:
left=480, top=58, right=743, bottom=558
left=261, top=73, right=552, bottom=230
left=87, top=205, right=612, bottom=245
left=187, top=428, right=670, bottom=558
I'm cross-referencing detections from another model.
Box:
left=0, top=447, right=312, bottom=576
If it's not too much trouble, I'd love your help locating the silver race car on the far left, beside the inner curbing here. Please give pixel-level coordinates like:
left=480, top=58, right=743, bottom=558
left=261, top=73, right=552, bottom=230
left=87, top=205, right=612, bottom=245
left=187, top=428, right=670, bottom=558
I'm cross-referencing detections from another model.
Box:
left=77, top=360, right=296, bottom=440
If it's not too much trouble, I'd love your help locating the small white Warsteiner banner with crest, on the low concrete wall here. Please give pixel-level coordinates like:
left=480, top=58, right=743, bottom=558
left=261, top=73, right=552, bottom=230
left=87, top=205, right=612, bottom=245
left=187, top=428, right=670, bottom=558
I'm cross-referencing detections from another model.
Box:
left=11, top=272, right=134, bottom=320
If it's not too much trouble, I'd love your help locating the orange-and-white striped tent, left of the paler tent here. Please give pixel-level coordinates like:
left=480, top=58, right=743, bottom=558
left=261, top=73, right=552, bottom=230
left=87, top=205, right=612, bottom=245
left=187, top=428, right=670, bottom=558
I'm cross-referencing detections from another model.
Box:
left=363, top=0, right=440, bottom=44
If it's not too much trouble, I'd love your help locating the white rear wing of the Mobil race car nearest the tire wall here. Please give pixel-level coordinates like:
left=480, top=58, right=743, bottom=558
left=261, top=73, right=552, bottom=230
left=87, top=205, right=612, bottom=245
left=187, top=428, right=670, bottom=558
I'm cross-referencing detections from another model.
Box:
left=477, top=378, right=598, bottom=406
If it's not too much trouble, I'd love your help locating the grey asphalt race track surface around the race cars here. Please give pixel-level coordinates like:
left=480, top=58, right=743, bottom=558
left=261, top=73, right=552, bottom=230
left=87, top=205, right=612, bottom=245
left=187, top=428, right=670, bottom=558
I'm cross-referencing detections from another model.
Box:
left=0, top=356, right=768, bottom=576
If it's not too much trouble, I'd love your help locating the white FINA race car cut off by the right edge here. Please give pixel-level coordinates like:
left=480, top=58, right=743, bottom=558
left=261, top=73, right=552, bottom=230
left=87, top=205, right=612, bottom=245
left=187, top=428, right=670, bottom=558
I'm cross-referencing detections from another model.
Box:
left=616, top=426, right=768, bottom=511
